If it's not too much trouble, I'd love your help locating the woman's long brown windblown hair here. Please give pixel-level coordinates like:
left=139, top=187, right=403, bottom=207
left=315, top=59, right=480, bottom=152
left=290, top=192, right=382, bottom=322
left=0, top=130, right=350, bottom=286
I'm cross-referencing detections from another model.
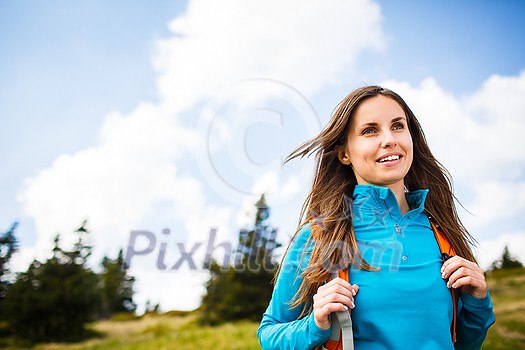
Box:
left=278, top=86, right=475, bottom=316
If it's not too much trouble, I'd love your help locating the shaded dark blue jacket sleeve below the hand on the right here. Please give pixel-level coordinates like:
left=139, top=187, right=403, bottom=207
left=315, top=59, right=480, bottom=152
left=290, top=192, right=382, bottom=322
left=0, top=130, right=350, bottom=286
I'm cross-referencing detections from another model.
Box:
left=455, top=293, right=496, bottom=350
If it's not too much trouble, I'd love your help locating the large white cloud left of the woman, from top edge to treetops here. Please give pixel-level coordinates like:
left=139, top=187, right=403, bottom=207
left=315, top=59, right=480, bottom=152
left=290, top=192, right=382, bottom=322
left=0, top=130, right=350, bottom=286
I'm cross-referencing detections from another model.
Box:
left=19, top=0, right=385, bottom=309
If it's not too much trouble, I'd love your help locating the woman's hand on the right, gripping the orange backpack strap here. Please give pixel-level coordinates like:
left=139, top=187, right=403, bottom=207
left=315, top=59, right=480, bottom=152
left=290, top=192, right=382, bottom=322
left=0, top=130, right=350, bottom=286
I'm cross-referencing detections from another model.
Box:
left=441, top=255, right=487, bottom=298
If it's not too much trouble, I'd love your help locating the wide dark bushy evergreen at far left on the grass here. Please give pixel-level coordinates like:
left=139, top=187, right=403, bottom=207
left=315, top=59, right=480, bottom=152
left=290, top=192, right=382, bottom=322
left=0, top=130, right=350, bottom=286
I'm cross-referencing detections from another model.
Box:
left=4, top=225, right=100, bottom=341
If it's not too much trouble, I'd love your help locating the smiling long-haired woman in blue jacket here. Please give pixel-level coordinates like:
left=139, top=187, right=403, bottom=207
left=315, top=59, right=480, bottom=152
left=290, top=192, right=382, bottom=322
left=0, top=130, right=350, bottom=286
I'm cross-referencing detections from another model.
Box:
left=257, top=86, right=494, bottom=350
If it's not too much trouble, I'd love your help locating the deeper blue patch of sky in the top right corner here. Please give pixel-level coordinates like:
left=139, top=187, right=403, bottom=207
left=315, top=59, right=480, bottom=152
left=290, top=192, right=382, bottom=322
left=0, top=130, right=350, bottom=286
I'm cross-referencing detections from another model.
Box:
left=372, top=0, right=525, bottom=94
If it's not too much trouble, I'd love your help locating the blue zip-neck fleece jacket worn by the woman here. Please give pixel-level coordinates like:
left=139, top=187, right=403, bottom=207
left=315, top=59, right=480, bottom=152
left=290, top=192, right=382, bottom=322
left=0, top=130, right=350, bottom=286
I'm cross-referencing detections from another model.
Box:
left=257, top=185, right=494, bottom=350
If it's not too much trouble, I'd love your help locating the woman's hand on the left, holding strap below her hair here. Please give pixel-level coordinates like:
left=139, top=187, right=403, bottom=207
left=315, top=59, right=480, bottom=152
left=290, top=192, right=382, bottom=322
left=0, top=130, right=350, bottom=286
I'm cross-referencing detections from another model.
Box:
left=314, top=277, right=359, bottom=329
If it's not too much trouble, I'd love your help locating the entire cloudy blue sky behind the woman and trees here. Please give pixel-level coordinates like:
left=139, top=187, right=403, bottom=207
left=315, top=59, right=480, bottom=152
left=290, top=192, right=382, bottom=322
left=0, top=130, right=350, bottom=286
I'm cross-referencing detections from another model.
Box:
left=0, top=0, right=525, bottom=310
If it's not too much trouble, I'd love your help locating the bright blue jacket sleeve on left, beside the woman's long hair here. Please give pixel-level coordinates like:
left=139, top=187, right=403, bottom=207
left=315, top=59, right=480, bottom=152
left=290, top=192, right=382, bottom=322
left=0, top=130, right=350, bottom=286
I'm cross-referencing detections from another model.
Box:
left=257, top=225, right=331, bottom=350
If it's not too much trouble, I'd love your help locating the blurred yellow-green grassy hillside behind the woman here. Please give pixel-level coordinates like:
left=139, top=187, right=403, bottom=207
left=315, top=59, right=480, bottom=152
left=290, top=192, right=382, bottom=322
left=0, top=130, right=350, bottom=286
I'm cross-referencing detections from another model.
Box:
left=0, top=269, right=525, bottom=350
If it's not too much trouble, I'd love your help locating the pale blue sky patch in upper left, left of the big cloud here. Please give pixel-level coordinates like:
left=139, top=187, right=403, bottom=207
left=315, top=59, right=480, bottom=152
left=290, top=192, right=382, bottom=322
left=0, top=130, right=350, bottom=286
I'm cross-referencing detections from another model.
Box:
left=0, top=0, right=184, bottom=224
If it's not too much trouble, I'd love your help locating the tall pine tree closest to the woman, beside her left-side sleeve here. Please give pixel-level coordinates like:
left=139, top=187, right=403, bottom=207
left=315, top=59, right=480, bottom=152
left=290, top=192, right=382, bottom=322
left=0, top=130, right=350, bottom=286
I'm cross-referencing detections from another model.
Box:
left=201, top=195, right=280, bottom=324
